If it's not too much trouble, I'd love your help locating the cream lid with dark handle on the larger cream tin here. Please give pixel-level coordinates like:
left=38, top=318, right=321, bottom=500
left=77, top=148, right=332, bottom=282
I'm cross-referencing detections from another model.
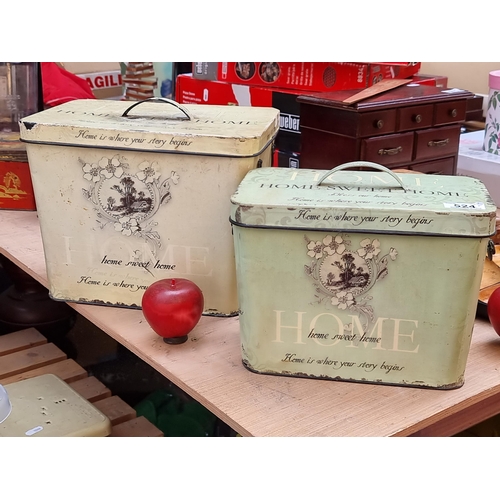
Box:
left=20, top=97, right=279, bottom=157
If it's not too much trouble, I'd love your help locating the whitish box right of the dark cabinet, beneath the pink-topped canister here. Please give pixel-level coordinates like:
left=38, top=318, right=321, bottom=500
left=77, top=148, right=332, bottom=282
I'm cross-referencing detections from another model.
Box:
left=457, top=130, right=500, bottom=207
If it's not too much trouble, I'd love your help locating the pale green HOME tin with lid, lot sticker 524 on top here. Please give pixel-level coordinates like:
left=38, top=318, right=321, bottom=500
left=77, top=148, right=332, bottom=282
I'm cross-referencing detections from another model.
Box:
left=230, top=162, right=496, bottom=389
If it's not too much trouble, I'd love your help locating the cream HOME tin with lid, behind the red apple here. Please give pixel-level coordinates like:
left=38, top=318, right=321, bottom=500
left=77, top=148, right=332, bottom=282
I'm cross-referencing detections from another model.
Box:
left=20, top=98, right=279, bottom=316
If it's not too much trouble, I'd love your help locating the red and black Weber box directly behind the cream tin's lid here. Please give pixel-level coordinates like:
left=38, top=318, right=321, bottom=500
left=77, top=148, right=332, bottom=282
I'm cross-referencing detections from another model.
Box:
left=175, top=74, right=306, bottom=152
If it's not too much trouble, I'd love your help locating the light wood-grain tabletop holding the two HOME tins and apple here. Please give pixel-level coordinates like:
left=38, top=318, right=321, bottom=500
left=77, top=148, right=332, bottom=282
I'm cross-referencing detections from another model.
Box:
left=0, top=210, right=500, bottom=436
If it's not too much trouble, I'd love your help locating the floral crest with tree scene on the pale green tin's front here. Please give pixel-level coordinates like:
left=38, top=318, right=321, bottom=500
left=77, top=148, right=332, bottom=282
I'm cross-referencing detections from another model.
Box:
left=304, top=233, right=398, bottom=331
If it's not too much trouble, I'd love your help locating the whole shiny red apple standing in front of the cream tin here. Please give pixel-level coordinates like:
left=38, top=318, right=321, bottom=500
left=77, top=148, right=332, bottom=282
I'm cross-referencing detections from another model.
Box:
left=142, top=278, right=204, bottom=344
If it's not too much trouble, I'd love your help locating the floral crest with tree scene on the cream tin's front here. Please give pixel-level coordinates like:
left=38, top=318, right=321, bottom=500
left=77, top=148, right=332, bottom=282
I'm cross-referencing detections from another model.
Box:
left=79, top=154, right=179, bottom=254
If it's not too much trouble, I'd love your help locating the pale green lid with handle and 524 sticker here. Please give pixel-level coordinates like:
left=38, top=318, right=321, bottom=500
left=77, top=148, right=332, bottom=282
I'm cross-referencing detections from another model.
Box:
left=230, top=161, right=496, bottom=237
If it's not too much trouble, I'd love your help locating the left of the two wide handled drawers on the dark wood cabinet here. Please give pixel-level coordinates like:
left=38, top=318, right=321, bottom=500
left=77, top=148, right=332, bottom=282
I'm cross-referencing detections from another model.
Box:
left=361, top=132, right=414, bottom=166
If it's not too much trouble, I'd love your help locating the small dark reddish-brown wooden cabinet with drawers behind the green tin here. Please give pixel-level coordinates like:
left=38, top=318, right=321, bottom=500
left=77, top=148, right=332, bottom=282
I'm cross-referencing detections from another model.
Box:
left=297, top=84, right=474, bottom=175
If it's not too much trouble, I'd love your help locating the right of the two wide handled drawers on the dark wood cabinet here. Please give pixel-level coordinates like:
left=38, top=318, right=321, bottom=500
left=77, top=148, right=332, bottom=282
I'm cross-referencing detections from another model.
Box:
left=414, top=125, right=460, bottom=161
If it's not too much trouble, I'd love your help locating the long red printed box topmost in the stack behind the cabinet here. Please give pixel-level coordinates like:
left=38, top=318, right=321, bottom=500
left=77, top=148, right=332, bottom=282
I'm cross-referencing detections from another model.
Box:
left=193, top=62, right=420, bottom=92
